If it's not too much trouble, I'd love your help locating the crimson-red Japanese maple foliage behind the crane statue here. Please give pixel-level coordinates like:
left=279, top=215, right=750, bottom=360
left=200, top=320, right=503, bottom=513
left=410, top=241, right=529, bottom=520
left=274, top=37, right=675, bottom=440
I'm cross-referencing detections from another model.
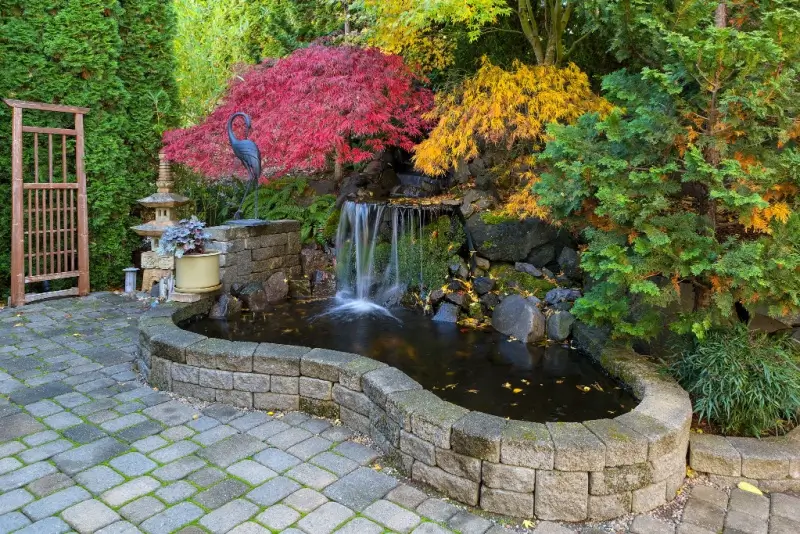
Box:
left=164, top=46, right=433, bottom=180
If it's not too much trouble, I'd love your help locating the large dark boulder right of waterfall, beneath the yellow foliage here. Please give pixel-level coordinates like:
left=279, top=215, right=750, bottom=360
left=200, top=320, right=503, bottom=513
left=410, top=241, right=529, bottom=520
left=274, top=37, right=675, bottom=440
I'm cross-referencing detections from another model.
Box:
left=467, top=213, right=556, bottom=262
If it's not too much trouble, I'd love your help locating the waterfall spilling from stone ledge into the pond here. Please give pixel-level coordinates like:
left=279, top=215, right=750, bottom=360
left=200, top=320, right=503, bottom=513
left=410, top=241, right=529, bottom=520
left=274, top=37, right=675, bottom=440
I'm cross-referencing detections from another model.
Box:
left=335, top=201, right=428, bottom=314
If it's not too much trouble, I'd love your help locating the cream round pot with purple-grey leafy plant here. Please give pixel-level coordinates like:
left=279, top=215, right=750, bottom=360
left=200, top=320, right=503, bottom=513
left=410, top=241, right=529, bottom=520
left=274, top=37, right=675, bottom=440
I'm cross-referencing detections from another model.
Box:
left=158, top=215, right=220, bottom=293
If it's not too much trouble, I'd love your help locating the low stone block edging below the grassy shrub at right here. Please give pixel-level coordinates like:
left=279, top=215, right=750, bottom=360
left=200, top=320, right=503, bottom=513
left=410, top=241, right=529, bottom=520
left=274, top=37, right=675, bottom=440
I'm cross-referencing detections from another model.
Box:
left=689, top=427, right=800, bottom=492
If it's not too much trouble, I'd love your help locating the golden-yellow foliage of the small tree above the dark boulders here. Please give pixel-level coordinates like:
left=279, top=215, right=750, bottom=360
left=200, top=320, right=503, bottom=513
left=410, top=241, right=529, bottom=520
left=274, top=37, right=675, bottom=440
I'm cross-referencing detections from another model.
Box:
left=414, top=58, right=611, bottom=176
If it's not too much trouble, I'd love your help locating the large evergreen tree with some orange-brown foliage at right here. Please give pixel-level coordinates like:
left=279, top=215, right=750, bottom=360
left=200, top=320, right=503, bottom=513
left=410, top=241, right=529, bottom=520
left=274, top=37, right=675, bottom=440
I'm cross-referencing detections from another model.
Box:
left=535, top=0, right=800, bottom=338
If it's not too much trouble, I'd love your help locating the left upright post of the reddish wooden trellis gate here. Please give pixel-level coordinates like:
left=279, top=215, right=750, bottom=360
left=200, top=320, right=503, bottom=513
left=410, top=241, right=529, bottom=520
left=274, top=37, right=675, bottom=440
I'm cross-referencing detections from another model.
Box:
left=11, top=108, right=25, bottom=306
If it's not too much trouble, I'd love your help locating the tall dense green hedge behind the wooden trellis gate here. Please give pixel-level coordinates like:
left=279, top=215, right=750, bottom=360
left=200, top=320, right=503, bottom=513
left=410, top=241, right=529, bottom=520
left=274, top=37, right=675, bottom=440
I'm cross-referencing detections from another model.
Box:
left=0, top=0, right=176, bottom=295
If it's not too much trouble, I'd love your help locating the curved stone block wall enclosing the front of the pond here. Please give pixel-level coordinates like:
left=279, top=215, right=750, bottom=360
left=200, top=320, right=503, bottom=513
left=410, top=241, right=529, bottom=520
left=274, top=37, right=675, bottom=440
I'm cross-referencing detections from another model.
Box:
left=139, top=301, right=691, bottom=521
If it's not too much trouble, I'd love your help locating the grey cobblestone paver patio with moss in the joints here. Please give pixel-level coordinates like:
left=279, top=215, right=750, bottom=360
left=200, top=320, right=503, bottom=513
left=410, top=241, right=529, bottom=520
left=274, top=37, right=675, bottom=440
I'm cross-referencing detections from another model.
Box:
left=0, top=293, right=800, bottom=534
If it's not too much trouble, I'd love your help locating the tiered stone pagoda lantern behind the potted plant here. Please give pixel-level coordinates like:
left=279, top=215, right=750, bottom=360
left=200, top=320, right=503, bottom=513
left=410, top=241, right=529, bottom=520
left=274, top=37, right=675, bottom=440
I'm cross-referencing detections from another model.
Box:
left=131, top=151, right=189, bottom=292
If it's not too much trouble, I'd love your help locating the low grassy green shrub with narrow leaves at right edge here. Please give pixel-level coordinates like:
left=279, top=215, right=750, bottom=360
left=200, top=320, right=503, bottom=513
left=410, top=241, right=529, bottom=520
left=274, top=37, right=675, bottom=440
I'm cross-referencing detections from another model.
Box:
left=671, top=326, right=800, bottom=436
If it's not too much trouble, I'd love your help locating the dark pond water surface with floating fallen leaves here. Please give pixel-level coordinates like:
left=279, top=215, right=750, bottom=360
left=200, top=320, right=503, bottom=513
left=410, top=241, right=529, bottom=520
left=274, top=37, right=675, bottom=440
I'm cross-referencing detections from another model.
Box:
left=181, top=301, right=637, bottom=422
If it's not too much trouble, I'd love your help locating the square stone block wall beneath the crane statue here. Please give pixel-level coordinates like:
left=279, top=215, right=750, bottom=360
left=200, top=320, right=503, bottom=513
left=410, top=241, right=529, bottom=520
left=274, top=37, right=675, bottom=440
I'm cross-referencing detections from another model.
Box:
left=206, top=220, right=302, bottom=292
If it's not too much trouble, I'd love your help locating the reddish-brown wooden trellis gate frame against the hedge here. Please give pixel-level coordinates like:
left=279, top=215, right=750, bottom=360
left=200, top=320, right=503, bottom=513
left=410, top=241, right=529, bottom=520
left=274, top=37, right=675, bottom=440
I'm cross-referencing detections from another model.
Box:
left=4, top=99, right=89, bottom=306
